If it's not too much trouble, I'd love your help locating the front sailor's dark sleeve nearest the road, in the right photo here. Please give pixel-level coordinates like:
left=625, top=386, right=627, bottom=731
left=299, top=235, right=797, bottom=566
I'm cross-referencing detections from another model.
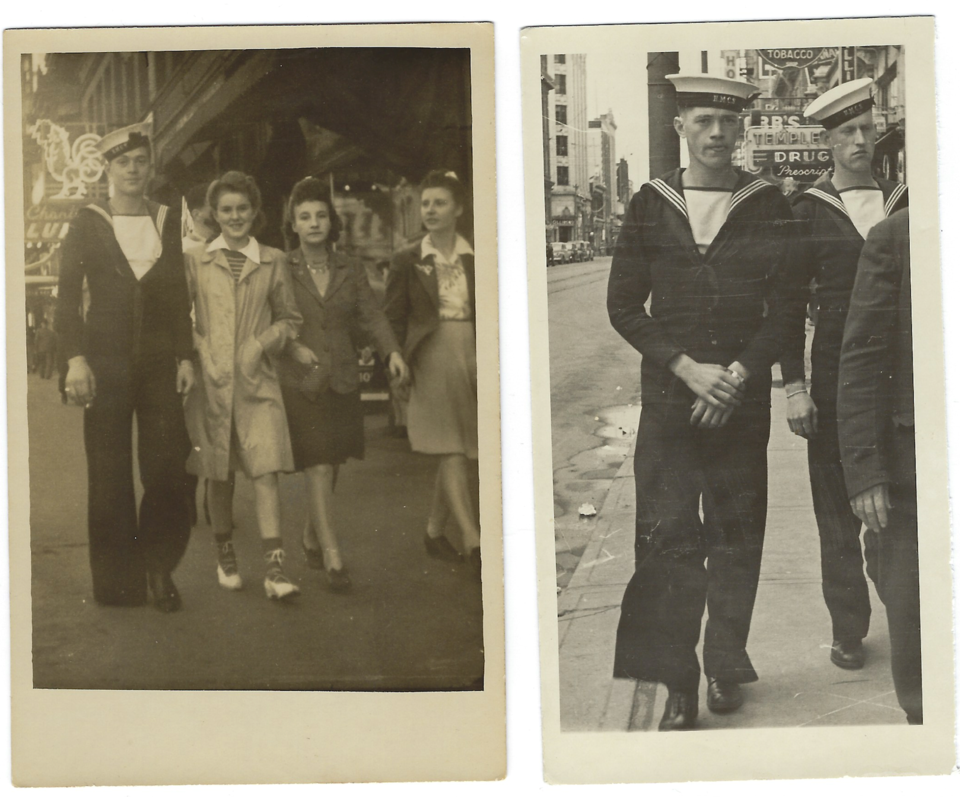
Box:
left=607, top=189, right=684, bottom=367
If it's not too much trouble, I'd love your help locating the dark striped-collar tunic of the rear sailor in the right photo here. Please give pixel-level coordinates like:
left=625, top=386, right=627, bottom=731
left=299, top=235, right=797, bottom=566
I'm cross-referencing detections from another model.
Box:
left=780, top=175, right=907, bottom=416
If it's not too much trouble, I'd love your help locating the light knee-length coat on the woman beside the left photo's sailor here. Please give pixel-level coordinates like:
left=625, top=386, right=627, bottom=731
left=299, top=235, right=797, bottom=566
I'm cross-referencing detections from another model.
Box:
left=184, top=244, right=302, bottom=481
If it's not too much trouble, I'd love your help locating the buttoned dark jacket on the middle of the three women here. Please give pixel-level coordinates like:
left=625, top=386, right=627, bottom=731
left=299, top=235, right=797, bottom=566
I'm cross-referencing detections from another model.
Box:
left=280, top=249, right=400, bottom=393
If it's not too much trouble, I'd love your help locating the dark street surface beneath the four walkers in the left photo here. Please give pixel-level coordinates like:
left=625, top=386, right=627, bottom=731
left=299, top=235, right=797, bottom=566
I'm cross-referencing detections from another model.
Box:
left=27, top=374, right=483, bottom=691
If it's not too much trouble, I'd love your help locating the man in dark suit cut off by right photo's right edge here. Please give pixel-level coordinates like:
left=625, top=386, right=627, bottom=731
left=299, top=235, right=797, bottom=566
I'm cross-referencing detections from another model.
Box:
left=837, top=209, right=923, bottom=725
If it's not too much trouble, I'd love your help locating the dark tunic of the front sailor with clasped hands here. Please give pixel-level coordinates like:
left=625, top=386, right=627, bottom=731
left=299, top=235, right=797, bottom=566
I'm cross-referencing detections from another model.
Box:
left=607, top=169, right=792, bottom=406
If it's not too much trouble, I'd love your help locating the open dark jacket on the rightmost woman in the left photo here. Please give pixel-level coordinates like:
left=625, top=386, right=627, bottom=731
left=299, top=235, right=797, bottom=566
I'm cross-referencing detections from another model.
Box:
left=384, top=243, right=477, bottom=365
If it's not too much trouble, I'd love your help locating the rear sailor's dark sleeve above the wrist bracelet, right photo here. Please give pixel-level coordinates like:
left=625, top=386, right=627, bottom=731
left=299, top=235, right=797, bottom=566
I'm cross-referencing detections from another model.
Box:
left=778, top=200, right=817, bottom=385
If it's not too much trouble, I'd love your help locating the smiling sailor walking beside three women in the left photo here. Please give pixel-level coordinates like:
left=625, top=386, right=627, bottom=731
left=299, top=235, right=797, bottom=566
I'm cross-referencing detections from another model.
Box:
left=56, top=125, right=194, bottom=612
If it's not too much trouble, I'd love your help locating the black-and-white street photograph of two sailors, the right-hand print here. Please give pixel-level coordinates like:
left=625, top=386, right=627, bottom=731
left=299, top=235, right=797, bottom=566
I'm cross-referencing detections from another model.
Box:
left=524, top=17, right=952, bottom=784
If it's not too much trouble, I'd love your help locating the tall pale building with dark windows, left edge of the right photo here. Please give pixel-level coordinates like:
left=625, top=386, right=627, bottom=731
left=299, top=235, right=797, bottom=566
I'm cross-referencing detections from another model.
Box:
left=549, top=54, right=592, bottom=241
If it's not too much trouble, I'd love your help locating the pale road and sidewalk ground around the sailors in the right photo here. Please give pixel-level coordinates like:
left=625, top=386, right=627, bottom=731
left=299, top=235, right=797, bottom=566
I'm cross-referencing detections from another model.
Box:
left=548, top=258, right=904, bottom=731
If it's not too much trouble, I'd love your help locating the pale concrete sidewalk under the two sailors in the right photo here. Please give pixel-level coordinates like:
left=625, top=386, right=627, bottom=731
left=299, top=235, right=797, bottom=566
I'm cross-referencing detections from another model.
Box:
left=558, top=376, right=905, bottom=731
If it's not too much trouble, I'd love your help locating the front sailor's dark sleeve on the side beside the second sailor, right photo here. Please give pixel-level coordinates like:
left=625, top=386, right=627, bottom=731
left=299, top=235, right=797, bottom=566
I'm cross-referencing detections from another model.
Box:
left=737, top=192, right=795, bottom=374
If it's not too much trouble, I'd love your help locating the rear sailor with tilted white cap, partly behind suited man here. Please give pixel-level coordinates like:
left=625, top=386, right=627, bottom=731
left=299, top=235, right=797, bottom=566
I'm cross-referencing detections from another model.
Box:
left=780, top=78, right=907, bottom=669
